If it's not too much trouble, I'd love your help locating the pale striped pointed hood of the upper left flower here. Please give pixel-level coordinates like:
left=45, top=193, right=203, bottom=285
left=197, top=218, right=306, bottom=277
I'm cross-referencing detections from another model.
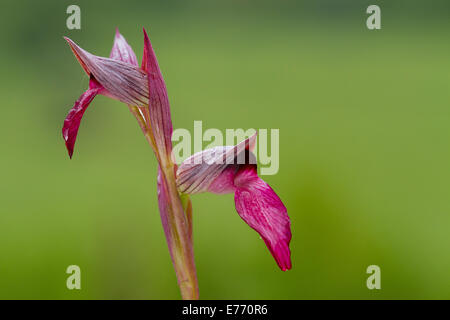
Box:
left=65, top=37, right=148, bottom=105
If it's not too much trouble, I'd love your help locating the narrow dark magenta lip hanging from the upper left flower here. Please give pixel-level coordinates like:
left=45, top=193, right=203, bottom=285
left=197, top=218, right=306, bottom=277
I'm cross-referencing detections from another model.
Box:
left=62, top=80, right=103, bottom=158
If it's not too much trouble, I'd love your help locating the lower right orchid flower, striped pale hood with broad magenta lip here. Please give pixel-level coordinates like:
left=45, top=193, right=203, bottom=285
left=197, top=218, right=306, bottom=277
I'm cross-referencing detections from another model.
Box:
left=177, top=134, right=291, bottom=271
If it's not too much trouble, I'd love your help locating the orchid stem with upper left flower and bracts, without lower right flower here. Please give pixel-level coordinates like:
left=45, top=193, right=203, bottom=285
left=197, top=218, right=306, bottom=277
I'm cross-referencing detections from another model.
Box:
left=62, top=30, right=198, bottom=299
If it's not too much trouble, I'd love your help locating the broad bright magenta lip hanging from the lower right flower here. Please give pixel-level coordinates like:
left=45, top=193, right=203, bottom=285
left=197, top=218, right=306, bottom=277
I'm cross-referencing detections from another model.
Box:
left=234, top=165, right=291, bottom=271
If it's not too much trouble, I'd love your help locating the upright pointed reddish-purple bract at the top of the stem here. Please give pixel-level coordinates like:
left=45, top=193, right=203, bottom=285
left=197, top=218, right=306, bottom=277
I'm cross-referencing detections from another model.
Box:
left=142, top=29, right=173, bottom=161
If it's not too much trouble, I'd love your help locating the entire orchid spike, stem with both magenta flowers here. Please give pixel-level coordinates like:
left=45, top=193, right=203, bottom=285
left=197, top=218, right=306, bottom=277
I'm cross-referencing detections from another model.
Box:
left=62, top=29, right=291, bottom=299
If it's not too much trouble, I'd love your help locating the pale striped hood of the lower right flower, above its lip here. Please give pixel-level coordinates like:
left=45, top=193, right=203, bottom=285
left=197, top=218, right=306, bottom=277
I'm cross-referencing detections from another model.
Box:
left=177, top=133, right=256, bottom=194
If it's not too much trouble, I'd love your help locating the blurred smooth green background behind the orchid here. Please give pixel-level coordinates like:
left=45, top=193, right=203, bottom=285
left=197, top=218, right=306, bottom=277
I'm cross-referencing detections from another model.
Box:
left=0, top=0, right=450, bottom=299
